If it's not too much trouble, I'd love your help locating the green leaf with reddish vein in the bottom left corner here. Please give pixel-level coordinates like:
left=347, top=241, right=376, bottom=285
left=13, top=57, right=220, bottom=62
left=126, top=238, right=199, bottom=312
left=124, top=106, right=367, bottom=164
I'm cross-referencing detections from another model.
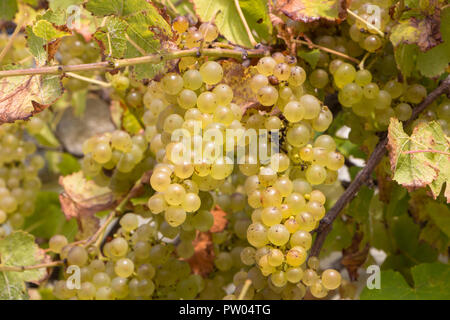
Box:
left=0, top=231, right=47, bottom=300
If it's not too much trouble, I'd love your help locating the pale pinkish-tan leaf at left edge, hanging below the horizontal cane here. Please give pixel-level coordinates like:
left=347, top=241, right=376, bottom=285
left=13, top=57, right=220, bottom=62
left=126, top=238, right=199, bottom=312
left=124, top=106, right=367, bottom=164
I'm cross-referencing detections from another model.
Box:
left=0, top=75, right=63, bottom=124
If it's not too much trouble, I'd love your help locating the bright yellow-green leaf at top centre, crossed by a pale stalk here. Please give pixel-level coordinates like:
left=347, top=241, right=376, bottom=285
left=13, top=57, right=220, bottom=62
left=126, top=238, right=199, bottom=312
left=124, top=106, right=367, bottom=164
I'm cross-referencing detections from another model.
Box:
left=193, top=0, right=272, bottom=47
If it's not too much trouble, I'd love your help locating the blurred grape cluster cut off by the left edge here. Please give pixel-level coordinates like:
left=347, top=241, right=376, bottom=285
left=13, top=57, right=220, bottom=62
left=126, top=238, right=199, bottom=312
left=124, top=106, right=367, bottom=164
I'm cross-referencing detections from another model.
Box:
left=0, top=122, right=45, bottom=237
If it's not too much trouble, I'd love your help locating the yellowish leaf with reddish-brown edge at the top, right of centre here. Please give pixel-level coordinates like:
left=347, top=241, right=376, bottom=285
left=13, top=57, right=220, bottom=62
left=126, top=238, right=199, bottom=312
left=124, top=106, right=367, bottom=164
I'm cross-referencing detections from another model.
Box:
left=277, top=0, right=347, bottom=23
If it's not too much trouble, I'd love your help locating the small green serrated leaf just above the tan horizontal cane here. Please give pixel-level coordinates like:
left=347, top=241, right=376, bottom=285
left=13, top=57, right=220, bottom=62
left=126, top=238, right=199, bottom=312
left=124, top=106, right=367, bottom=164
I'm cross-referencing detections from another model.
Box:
left=94, top=17, right=128, bottom=58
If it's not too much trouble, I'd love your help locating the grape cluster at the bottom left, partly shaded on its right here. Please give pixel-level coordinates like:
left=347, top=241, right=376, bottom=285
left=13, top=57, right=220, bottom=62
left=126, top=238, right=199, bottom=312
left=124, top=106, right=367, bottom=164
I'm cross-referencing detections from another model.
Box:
left=49, top=213, right=204, bottom=300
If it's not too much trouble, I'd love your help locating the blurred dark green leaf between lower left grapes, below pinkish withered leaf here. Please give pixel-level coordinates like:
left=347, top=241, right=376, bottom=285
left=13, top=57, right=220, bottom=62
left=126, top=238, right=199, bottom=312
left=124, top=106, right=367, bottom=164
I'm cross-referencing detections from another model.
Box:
left=23, top=191, right=78, bottom=241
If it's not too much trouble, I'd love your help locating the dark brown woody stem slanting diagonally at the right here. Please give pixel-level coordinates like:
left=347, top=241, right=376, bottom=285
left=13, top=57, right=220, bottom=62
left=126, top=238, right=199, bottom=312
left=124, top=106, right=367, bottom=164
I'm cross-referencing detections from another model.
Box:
left=310, top=76, right=450, bottom=257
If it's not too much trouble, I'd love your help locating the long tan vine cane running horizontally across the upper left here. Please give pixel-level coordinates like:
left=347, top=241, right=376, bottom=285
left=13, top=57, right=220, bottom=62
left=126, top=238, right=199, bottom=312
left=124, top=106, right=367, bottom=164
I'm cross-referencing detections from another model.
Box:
left=0, top=48, right=265, bottom=78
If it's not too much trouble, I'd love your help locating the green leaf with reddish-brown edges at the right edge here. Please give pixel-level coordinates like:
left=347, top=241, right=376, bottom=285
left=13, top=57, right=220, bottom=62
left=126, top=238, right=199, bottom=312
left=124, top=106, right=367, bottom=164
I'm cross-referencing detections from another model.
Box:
left=388, top=118, right=450, bottom=202
